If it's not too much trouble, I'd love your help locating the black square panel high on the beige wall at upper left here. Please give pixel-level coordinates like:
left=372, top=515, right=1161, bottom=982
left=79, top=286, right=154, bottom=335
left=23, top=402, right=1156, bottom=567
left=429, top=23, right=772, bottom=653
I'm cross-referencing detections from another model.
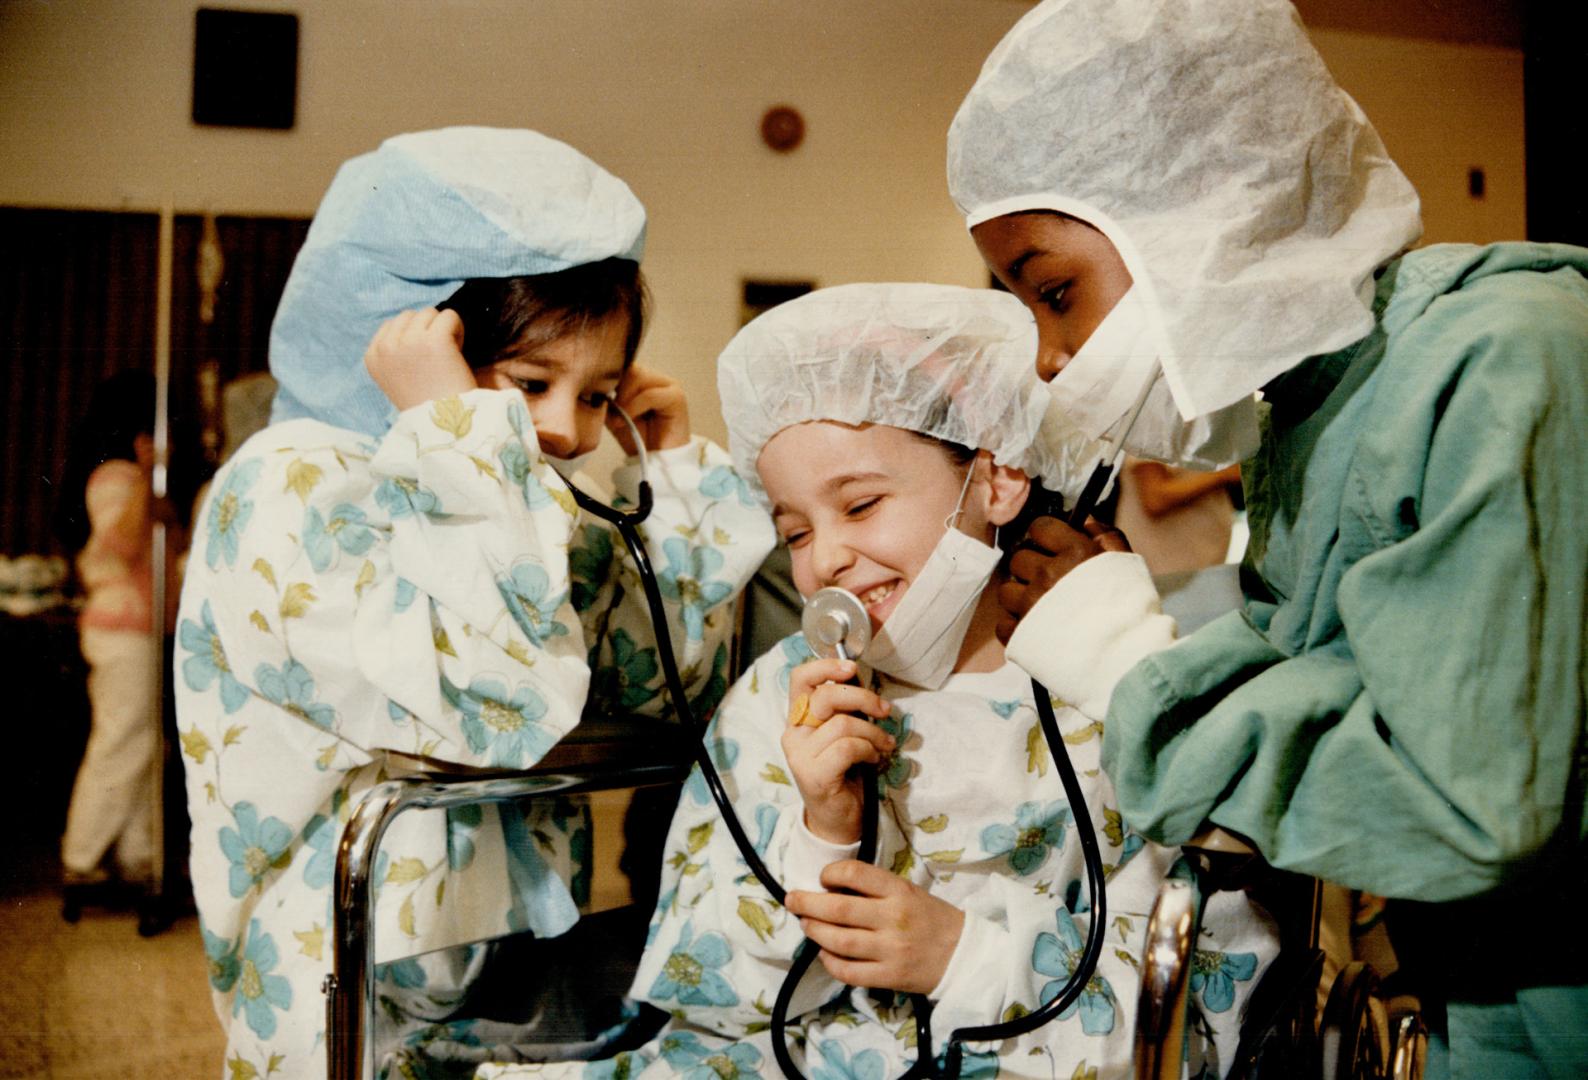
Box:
left=194, top=8, right=297, bottom=129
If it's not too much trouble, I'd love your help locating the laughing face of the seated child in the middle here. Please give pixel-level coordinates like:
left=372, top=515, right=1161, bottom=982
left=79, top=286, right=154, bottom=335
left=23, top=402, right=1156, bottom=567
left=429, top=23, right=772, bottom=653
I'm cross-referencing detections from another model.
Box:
left=756, top=421, right=1026, bottom=631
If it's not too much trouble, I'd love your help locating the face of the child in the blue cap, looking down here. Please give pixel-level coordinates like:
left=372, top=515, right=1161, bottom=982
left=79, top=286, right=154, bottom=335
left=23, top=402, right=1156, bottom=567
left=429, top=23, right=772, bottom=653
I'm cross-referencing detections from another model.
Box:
left=465, top=314, right=629, bottom=457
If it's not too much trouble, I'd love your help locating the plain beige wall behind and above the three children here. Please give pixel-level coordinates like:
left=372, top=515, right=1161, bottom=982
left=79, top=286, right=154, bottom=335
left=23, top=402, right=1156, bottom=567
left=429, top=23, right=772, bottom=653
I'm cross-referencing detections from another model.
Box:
left=0, top=0, right=1524, bottom=435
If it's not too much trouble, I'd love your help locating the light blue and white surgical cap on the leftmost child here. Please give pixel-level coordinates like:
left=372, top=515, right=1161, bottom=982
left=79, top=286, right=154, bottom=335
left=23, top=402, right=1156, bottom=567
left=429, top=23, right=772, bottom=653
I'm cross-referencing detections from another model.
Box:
left=270, top=127, right=645, bottom=435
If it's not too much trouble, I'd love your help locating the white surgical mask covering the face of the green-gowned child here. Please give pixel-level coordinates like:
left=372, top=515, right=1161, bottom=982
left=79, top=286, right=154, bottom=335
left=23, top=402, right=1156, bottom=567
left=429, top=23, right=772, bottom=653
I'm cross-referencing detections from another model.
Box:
left=1048, top=286, right=1258, bottom=469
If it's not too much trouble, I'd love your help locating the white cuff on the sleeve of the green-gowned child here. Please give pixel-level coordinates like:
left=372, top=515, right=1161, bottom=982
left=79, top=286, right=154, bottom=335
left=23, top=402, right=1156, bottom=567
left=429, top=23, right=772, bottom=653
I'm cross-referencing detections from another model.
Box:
left=1004, top=551, right=1175, bottom=719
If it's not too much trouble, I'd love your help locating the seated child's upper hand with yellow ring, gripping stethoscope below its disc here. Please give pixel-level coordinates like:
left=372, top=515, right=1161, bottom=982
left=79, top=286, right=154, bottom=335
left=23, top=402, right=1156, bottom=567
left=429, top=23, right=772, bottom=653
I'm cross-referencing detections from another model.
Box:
left=783, top=659, right=894, bottom=843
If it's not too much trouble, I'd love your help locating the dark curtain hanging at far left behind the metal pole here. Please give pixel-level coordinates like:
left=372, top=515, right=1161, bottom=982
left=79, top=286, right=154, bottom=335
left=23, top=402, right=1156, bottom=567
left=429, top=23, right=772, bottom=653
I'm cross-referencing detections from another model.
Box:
left=0, top=208, right=308, bottom=556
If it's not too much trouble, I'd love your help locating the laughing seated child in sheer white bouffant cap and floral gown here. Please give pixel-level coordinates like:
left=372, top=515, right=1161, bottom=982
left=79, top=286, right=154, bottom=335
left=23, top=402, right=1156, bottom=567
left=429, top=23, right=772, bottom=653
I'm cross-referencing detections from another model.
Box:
left=481, top=284, right=1274, bottom=1080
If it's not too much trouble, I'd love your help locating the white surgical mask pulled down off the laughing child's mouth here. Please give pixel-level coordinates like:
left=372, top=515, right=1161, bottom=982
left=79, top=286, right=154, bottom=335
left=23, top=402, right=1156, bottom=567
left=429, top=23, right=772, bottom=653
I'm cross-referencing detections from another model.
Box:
left=861, top=464, right=1000, bottom=689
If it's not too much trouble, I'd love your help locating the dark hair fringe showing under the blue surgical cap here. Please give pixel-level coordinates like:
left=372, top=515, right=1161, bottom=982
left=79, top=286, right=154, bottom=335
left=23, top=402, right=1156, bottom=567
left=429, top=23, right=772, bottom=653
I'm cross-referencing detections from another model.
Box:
left=437, top=259, right=649, bottom=368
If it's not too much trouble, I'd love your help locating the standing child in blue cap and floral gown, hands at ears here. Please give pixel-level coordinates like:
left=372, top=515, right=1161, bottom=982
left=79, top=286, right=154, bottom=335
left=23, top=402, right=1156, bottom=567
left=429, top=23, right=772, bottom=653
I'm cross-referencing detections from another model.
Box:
left=176, top=129, right=772, bottom=1077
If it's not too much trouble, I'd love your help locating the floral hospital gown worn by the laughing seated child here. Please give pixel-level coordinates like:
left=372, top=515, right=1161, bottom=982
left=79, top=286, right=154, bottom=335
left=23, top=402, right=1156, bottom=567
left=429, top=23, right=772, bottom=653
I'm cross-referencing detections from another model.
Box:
left=480, top=637, right=1277, bottom=1080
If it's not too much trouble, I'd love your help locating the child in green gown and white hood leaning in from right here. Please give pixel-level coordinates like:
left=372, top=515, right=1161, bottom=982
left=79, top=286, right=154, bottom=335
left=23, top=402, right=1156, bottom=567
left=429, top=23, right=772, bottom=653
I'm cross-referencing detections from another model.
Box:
left=948, top=0, right=1588, bottom=1077
